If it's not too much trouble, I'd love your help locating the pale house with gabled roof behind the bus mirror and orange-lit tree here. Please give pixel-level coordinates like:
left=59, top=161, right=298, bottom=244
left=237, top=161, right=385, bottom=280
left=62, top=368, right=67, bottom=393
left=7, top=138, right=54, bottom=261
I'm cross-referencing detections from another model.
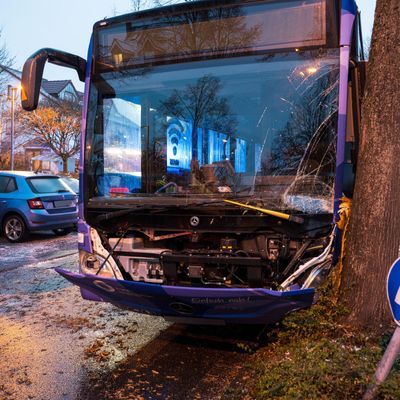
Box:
left=0, top=65, right=83, bottom=173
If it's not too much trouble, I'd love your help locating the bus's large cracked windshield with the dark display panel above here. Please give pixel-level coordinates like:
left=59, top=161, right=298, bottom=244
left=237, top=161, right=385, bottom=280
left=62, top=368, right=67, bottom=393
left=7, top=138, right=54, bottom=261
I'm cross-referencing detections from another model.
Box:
left=87, top=1, right=339, bottom=213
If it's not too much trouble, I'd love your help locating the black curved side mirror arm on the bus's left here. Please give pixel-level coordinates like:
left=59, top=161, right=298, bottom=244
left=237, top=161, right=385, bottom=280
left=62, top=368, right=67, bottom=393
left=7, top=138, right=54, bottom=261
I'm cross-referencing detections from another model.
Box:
left=21, top=49, right=86, bottom=111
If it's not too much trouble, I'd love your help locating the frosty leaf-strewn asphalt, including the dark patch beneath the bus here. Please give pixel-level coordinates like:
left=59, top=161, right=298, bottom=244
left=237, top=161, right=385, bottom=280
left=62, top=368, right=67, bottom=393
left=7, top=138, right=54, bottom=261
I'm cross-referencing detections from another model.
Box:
left=0, top=233, right=253, bottom=400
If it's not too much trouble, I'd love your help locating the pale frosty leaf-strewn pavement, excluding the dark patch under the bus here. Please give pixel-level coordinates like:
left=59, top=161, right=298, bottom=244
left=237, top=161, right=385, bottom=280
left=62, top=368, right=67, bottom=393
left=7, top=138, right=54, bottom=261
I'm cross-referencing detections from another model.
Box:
left=0, top=233, right=168, bottom=400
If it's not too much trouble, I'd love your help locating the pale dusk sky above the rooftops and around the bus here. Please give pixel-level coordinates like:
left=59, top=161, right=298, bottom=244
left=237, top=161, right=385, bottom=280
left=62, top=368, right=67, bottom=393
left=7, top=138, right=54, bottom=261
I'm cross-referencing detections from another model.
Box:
left=0, top=0, right=375, bottom=90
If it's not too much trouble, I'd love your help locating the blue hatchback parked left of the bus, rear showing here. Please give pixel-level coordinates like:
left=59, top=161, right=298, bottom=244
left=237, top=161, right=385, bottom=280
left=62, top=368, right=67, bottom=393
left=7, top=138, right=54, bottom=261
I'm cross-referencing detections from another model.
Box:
left=0, top=171, right=78, bottom=242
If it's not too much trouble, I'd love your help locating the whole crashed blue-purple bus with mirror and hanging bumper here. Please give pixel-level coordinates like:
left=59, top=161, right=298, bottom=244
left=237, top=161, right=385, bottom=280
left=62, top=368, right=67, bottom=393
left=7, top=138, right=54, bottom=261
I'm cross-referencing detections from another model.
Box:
left=22, top=0, right=365, bottom=324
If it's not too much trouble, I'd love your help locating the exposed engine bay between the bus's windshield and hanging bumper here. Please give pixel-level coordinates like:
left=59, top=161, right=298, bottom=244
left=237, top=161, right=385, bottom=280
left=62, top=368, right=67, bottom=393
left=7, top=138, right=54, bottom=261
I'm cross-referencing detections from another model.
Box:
left=81, top=228, right=333, bottom=290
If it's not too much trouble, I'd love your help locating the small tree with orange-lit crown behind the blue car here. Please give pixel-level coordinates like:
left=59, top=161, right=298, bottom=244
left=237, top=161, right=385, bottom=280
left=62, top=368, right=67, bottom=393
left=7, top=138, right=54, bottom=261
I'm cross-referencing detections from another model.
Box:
left=22, top=102, right=81, bottom=173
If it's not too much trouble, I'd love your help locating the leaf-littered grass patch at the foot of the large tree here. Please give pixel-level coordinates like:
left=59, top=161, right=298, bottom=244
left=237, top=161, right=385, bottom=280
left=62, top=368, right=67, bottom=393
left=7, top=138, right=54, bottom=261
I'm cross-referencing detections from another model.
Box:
left=239, top=287, right=400, bottom=400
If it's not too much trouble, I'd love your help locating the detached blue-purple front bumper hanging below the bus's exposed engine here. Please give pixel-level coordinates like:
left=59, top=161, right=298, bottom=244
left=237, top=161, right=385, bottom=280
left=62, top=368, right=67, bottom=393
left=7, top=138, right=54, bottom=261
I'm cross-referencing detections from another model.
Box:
left=56, top=268, right=315, bottom=324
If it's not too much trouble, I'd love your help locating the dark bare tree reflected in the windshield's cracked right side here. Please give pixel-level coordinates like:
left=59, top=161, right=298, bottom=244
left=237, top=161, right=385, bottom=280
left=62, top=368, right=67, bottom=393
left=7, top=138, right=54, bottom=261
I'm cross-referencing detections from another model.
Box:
left=268, top=66, right=339, bottom=177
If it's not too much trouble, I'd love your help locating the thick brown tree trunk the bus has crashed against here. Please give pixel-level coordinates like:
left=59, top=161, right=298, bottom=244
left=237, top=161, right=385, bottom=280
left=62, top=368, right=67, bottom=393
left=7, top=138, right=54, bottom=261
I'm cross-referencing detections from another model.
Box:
left=342, top=0, right=400, bottom=331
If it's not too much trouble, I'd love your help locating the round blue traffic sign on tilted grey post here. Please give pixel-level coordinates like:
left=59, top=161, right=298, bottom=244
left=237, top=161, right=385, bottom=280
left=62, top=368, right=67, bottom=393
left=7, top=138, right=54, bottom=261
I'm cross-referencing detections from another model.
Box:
left=363, top=258, right=400, bottom=400
